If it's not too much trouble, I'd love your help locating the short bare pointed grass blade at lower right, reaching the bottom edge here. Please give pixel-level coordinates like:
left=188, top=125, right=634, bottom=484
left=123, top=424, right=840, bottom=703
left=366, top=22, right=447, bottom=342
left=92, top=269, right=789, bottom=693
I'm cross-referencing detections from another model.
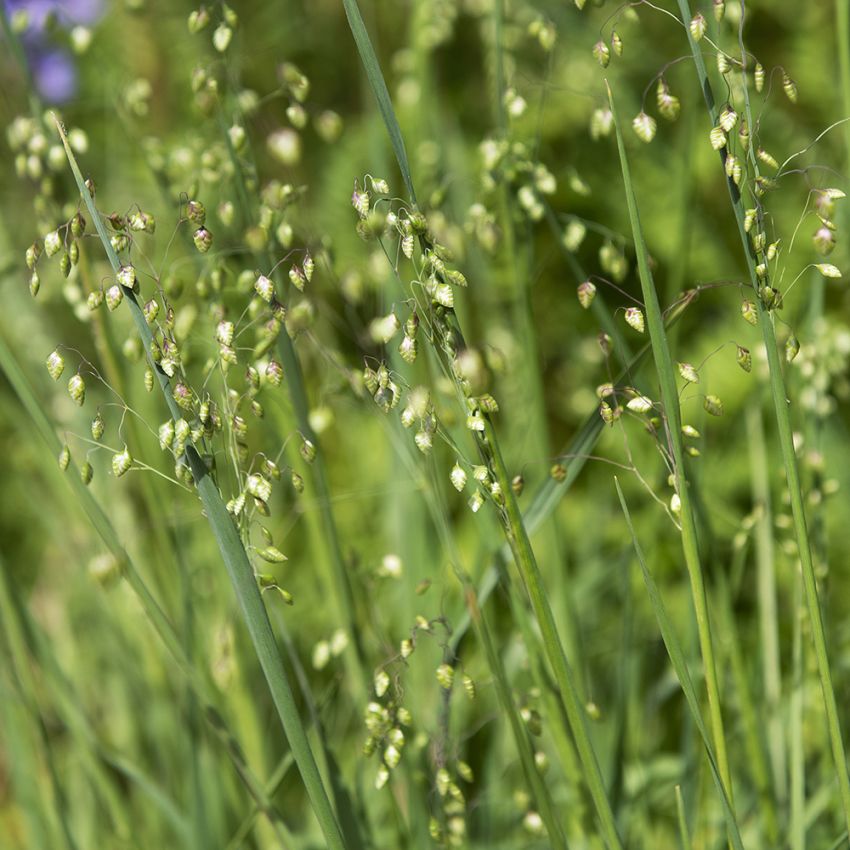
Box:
left=614, top=477, right=744, bottom=850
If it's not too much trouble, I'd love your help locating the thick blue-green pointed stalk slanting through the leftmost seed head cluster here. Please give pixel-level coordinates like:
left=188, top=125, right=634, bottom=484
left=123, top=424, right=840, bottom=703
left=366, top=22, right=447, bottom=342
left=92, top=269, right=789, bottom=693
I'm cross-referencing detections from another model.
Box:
left=57, top=121, right=346, bottom=850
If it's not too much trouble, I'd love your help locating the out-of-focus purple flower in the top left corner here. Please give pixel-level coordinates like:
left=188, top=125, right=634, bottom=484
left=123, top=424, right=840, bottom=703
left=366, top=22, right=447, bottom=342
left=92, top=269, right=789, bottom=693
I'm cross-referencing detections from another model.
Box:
left=3, top=0, right=103, bottom=103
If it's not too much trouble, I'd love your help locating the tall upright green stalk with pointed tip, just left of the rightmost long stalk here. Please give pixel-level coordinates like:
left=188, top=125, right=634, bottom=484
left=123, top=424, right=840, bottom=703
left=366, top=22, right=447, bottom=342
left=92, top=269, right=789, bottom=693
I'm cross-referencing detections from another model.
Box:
left=608, top=83, right=732, bottom=801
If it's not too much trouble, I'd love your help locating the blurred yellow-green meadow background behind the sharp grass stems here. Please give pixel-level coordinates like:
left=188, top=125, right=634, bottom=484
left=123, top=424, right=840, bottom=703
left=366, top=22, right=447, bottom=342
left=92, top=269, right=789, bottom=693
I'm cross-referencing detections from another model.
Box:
left=0, top=0, right=850, bottom=848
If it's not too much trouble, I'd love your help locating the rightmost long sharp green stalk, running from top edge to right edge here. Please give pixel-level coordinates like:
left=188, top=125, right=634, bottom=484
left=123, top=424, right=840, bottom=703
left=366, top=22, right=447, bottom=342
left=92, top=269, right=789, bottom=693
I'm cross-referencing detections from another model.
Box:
left=678, top=0, right=850, bottom=829
